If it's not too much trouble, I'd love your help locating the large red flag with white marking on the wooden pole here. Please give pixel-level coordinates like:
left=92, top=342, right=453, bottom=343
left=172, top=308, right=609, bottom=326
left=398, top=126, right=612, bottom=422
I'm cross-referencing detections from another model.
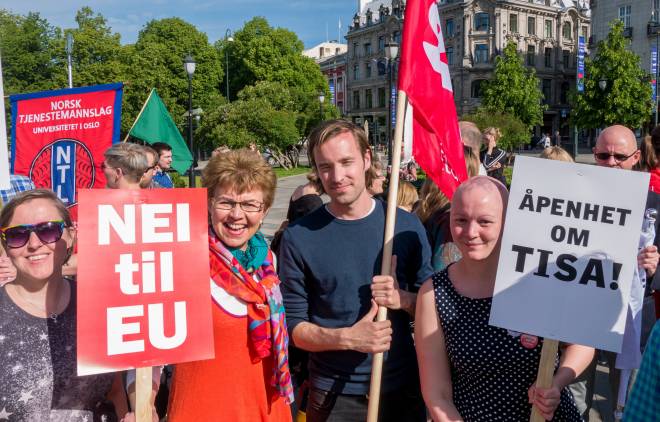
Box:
left=399, top=0, right=467, bottom=199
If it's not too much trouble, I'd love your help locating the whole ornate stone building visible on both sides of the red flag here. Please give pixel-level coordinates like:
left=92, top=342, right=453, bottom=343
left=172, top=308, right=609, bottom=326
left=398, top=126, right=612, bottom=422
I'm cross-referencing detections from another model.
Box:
left=346, top=0, right=592, bottom=142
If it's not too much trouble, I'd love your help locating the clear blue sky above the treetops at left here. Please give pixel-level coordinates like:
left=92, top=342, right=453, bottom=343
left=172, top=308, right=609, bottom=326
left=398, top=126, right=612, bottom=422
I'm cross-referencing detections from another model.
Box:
left=0, top=0, right=357, bottom=48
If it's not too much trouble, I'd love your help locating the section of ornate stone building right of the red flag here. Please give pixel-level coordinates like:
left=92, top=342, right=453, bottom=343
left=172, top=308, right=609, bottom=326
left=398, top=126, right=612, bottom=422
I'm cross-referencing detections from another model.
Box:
left=438, top=0, right=591, bottom=136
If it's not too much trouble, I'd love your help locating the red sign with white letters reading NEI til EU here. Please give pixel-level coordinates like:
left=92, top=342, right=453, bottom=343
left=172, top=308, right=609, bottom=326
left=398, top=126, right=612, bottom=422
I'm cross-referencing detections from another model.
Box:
left=77, top=189, right=214, bottom=375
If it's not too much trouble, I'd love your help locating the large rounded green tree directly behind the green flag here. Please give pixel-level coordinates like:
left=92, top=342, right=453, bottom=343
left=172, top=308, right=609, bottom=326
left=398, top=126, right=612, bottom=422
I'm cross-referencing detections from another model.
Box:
left=122, top=18, right=224, bottom=134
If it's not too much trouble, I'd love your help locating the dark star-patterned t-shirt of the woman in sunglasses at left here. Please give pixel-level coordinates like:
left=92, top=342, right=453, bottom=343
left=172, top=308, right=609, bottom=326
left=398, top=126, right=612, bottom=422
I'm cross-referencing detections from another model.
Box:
left=0, top=281, right=114, bottom=422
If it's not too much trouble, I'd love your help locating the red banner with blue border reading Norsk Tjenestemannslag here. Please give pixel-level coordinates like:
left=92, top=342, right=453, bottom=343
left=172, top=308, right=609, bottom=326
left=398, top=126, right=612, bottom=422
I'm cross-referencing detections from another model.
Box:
left=10, top=84, right=123, bottom=220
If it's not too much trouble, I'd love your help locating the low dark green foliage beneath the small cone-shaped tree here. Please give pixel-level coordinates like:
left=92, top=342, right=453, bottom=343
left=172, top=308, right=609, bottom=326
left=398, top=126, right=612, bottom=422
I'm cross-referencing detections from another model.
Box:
left=461, top=107, right=529, bottom=151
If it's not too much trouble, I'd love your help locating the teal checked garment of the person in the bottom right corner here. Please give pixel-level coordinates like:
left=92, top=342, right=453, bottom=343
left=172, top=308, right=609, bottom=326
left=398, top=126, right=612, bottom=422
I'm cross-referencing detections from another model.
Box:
left=623, top=320, right=660, bottom=422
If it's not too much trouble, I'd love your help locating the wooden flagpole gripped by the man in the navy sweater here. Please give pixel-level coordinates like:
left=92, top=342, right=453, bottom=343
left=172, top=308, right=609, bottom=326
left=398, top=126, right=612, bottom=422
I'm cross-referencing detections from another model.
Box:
left=367, top=91, right=407, bottom=422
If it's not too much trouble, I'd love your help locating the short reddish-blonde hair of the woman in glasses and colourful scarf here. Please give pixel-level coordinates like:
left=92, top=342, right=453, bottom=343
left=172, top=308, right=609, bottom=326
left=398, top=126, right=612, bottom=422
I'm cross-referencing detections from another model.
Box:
left=202, top=148, right=277, bottom=209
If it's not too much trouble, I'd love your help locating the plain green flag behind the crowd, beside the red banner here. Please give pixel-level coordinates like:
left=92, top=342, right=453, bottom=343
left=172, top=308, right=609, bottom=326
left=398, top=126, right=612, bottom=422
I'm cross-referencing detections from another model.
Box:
left=128, top=88, right=192, bottom=173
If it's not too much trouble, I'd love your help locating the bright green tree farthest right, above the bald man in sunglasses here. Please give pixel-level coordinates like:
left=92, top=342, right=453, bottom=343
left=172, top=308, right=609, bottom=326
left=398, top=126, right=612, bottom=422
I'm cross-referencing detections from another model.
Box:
left=571, top=20, right=653, bottom=129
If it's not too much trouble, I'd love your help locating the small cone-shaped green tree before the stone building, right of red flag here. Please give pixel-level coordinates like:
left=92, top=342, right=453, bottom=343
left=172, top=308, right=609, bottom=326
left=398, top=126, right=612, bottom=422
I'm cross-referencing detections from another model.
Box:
left=482, top=43, right=545, bottom=130
